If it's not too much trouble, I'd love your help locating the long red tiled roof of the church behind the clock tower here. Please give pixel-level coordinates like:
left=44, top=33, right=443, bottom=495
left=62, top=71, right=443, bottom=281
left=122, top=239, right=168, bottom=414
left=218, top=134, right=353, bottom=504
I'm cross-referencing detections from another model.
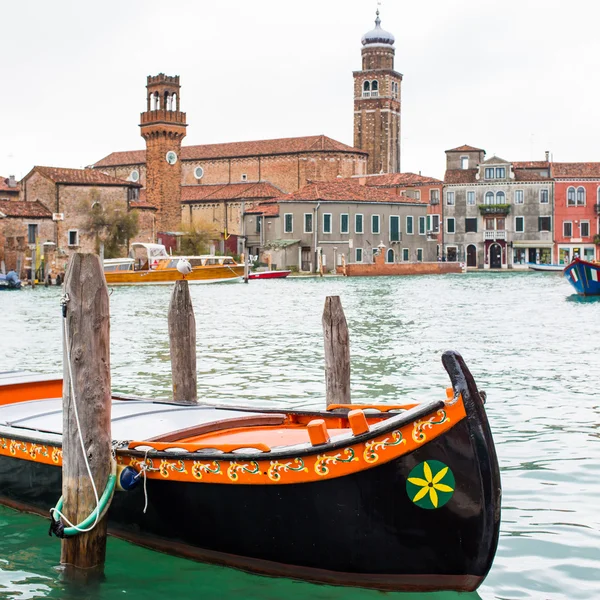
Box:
left=94, top=135, right=367, bottom=168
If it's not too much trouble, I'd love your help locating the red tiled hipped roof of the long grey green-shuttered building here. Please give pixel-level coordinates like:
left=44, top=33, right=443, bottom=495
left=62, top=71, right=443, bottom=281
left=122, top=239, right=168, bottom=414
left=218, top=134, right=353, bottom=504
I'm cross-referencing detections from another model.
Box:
left=272, top=179, right=427, bottom=204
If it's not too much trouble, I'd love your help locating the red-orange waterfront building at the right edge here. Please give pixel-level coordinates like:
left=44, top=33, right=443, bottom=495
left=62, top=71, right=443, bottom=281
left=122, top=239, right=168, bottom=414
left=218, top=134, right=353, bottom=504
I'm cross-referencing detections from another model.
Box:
left=551, top=162, right=600, bottom=265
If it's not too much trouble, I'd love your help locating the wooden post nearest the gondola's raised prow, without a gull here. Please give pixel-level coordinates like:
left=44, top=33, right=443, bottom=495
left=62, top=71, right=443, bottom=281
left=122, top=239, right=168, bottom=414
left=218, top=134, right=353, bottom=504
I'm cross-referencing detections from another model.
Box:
left=323, top=296, right=351, bottom=406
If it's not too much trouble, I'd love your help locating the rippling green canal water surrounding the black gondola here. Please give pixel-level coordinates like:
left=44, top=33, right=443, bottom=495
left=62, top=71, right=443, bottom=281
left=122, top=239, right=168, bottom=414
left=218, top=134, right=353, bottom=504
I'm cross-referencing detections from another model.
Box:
left=0, top=273, right=600, bottom=600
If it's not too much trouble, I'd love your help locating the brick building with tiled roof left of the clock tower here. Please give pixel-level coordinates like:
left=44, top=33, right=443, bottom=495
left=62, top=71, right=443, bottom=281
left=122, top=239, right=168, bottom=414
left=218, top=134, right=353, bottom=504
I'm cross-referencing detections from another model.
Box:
left=21, top=166, right=143, bottom=258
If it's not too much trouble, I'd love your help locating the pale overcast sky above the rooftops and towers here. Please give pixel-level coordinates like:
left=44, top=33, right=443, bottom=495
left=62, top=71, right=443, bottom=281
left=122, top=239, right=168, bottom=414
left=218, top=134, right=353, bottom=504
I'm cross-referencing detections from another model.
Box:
left=0, top=0, right=600, bottom=178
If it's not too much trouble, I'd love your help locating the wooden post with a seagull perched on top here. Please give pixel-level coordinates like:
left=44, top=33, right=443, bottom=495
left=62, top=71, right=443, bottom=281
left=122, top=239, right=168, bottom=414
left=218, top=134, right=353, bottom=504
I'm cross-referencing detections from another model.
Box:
left=169, top=279, right=198, bottom=404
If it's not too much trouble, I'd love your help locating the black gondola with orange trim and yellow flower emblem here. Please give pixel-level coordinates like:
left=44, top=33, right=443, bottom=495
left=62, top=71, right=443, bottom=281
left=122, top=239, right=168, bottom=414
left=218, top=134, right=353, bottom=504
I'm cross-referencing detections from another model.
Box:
left=0, top=352, right=501, bottom=591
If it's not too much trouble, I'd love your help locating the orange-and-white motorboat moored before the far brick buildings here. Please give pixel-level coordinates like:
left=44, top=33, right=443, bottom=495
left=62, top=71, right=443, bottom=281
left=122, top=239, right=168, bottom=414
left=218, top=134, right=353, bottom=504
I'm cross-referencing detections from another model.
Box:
left=104, top=243, right=244, bottom=286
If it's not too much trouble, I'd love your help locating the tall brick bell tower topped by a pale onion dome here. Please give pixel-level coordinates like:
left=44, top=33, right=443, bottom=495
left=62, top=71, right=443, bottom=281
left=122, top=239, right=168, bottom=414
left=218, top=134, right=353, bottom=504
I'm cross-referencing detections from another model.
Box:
left=354, top=10, right=402, bottom=173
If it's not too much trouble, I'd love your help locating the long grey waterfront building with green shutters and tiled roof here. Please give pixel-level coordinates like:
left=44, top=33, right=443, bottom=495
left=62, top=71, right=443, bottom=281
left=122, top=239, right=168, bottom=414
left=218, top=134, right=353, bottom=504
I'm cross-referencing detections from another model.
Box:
left=244, top=179, right=436, bottom=272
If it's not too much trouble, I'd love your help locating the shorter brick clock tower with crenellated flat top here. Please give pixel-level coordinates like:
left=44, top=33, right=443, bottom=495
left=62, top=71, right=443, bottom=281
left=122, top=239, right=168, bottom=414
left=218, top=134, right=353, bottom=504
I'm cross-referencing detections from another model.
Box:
left=140, top=73, right=187, bottom=232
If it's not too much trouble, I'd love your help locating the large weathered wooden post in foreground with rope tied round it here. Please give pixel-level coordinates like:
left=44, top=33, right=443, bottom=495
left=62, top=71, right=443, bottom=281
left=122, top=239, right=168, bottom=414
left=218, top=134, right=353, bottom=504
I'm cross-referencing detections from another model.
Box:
left=60, top=253, right=112, bottom=581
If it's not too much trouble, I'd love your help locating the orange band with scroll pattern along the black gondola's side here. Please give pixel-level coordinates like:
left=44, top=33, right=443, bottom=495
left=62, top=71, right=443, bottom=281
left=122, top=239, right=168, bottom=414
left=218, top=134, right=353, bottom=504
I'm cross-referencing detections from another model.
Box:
left=0, top=401, right=466, bottom=485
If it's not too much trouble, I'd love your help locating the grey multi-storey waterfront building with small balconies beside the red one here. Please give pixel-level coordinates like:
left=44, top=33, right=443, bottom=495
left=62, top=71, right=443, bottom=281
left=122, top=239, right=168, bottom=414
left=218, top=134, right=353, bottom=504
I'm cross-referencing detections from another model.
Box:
left=442, top=145, right=554, bottom=269
